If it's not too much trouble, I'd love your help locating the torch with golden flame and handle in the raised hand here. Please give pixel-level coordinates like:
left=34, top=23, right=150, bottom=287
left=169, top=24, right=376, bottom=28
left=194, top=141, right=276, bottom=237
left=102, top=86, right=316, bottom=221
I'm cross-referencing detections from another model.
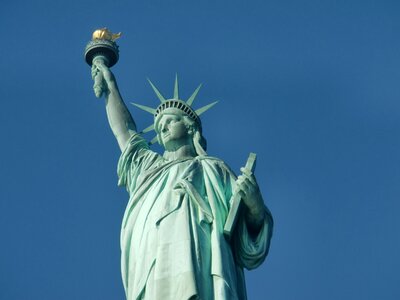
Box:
left=85, top=28, right=121, bottom=98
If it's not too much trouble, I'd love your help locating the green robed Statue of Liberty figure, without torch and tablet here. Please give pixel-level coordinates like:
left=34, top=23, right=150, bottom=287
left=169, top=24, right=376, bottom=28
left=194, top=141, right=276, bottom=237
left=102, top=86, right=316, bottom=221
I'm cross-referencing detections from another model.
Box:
left=86, top=28, right=273, bottom=300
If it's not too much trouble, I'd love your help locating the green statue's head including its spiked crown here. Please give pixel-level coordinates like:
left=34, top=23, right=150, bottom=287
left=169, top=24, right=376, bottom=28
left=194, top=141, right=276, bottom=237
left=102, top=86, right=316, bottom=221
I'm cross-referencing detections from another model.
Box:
left=132, top=78, right=217, bottom=155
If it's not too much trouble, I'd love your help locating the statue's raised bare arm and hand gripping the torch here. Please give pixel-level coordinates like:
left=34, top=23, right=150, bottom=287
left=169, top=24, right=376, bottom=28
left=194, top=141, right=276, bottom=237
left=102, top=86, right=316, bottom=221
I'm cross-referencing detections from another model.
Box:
left=92, top=60, right=136, bottom=151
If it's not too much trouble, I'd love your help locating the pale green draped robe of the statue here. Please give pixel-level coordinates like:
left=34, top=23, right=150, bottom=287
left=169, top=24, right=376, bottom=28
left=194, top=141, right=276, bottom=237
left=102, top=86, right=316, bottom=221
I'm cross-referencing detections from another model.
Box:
left=118, top=134, right=272, bottom=300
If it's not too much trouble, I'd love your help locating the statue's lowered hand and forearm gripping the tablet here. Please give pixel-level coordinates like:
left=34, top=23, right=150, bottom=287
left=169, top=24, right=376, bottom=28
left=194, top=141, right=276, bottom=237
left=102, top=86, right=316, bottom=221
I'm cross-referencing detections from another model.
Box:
left=236, top=168, right=265, bottom=231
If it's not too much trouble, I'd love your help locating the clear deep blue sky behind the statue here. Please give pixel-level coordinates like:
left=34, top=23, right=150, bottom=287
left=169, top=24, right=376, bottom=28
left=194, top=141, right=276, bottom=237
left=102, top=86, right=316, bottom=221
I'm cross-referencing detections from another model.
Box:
left=0, top=0, right=400, bottom=300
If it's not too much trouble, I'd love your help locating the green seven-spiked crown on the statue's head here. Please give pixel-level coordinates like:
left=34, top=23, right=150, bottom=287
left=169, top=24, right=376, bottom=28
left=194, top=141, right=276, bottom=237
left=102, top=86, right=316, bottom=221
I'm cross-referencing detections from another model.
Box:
left=131, top=75, right=218, bottom=144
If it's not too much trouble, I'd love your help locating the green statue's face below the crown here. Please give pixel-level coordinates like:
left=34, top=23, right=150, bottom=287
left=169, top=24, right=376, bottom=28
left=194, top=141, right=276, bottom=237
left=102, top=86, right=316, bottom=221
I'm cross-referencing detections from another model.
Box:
left=157, top=111, right=191, bottom=151
